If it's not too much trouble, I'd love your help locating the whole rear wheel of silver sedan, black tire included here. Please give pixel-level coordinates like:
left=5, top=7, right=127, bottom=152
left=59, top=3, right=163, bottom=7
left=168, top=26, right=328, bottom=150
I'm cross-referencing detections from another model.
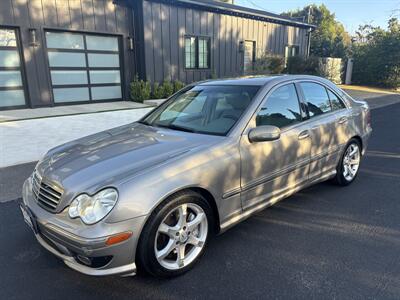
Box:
left=334, top=138, right=361, bottom=186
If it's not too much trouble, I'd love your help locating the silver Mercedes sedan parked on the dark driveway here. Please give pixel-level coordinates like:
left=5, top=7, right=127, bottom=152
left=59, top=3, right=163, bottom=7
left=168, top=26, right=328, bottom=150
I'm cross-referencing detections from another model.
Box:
left=20, top=76, right=371, bottom=277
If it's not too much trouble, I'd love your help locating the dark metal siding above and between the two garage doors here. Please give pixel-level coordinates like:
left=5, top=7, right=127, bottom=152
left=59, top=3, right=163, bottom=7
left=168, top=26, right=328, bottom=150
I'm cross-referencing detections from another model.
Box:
left=0, top=0, right=135, bottom=107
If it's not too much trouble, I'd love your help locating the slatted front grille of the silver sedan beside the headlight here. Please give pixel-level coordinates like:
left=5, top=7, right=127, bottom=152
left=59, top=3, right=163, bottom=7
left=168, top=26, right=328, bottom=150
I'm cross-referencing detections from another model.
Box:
left=32, top=171, right=62, bottom=211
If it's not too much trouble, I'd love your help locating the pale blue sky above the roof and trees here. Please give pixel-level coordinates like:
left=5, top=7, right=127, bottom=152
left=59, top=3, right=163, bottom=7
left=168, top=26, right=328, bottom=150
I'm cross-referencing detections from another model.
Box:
left=234, top=0, right=400, bottom=34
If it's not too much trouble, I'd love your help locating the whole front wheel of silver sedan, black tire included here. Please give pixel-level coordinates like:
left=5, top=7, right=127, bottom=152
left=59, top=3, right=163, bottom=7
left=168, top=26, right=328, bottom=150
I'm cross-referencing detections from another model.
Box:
left=136, top=191, right=214, bottom=278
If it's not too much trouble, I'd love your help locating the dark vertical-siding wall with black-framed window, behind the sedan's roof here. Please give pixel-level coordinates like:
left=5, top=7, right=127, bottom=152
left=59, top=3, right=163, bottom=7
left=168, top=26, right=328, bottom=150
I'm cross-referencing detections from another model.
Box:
left=143, top=1, right=307, bottom=83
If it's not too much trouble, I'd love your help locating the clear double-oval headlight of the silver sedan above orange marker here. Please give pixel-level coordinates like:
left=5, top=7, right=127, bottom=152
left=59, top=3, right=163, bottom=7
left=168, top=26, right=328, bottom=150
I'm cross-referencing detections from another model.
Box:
left=68, top=188, right=118, bottom=225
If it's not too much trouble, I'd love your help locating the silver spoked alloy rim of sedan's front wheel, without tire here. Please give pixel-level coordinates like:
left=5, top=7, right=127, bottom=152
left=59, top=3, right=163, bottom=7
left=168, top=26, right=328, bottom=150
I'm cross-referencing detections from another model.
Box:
left=154, top=203, right=208, bottom=270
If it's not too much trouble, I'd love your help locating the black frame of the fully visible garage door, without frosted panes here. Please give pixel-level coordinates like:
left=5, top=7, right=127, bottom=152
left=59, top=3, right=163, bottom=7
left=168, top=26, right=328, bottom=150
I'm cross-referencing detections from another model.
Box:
left=43, top=27, right=126, bottom=106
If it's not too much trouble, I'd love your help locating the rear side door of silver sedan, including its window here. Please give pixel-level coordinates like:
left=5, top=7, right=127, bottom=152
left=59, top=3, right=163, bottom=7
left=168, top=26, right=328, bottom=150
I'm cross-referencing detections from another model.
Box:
left=298, top=81, right=339, bottom=180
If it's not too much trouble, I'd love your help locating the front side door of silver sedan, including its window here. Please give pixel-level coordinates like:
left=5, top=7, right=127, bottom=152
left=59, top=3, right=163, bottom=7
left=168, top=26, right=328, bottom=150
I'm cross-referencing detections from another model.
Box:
left=240, top=84, right=311, bottom=209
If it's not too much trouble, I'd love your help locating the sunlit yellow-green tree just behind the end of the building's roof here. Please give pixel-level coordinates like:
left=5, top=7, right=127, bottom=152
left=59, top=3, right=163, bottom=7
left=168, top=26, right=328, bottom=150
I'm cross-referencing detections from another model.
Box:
left=282, top=4, right=351, bottom=58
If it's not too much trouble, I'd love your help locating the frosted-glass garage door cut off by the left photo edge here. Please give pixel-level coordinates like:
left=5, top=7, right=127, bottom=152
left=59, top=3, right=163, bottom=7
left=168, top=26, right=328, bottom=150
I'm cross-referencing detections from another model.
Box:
left=0, top=28, right=25, bottom=108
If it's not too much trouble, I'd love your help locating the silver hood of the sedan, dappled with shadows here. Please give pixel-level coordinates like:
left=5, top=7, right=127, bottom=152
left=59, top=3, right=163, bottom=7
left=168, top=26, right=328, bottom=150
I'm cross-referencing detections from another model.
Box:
left=36, top=123, right=221, bottom=198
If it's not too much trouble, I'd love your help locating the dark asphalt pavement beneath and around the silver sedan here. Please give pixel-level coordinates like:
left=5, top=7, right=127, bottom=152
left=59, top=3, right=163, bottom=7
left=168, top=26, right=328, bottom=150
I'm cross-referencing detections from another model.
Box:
left=0, top=99, right=400, bottom=300
